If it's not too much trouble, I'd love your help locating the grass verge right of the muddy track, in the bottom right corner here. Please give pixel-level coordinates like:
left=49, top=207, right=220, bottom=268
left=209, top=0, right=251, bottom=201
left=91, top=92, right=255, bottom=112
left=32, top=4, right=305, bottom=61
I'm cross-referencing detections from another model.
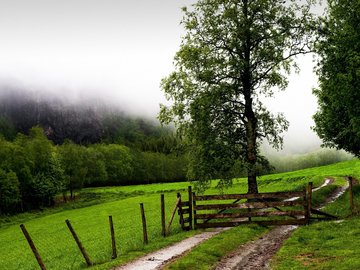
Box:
left=271, top=185, right=360, bottom=270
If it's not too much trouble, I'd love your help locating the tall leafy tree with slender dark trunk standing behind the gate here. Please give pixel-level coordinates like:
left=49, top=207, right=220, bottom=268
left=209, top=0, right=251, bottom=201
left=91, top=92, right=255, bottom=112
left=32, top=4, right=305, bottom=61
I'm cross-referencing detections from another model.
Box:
left=160, top=0, right=314, bottom=193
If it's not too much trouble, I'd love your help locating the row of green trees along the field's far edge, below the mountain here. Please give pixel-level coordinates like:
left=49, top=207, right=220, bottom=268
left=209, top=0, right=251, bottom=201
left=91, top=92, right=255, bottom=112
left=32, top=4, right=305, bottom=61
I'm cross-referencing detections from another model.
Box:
left=0, top=127, right=185, bottom=214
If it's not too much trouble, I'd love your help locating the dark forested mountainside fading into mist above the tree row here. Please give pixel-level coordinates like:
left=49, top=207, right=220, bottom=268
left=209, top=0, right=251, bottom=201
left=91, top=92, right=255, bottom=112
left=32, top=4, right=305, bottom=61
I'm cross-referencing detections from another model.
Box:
left=0, top=87, right=176, bottom=152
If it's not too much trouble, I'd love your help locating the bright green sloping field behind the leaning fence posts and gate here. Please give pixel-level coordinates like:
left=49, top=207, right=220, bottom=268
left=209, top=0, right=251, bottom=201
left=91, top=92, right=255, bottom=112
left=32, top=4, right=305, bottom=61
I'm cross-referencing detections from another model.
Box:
left=0, top=160, right=360, bottom=269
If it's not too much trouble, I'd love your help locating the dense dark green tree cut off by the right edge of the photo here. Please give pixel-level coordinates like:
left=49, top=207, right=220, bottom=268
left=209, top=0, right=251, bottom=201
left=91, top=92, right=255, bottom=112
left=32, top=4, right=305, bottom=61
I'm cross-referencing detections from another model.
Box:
left=314, top=0, right=360, bottom=157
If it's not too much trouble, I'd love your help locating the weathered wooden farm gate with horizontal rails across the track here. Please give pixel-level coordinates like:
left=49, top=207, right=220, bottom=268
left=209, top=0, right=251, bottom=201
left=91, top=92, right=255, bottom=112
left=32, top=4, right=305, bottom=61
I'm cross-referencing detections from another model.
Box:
left=189, top=185, right=311, bottom=229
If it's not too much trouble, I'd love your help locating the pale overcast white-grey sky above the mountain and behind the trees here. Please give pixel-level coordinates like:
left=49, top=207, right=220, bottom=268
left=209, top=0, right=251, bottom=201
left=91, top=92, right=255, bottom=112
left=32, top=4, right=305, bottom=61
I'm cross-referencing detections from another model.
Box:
left=0, top=0, right=326, bottom=154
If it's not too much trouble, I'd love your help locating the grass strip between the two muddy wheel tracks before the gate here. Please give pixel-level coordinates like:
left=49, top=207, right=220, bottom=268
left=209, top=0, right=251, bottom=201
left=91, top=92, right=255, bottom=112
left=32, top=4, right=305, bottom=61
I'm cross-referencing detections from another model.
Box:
left=164, top=225, right=268, bottom=270
